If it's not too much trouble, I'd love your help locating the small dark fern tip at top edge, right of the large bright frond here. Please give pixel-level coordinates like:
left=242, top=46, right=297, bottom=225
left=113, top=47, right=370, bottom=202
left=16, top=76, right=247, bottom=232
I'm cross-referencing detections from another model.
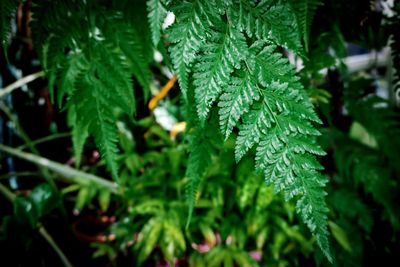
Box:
left=291, top=0, right=322, bottom=52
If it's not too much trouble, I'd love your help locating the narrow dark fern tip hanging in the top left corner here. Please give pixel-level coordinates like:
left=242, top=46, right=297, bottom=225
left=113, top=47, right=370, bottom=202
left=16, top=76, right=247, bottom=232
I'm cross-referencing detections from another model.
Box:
left=0, top=0, right=20, bottom=56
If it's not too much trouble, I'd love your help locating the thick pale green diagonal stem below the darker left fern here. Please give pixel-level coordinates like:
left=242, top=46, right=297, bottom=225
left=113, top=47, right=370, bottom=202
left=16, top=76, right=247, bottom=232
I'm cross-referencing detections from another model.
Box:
left=0, top=144, right=118, bottom=194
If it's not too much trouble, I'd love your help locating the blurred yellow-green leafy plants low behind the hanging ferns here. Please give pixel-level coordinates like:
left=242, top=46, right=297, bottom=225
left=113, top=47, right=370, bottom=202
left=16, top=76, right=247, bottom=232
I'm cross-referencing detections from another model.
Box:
left=96, top=120, right=313, bottom=266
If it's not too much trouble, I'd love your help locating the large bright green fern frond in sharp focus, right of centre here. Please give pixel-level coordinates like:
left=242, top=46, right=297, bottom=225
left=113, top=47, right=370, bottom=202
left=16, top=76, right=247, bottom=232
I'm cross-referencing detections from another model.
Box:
left=168, top=0, right=331, bottom=260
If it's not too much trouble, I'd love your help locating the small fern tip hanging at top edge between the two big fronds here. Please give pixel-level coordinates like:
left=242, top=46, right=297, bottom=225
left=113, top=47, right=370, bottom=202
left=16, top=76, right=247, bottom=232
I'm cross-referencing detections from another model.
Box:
left=147, top=0, right=167, bottom=47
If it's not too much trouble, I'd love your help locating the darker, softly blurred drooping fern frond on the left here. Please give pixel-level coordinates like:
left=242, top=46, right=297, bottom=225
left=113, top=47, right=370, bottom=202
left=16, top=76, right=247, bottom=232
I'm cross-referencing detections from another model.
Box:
left=32, top=1, right=150, bottom=178
